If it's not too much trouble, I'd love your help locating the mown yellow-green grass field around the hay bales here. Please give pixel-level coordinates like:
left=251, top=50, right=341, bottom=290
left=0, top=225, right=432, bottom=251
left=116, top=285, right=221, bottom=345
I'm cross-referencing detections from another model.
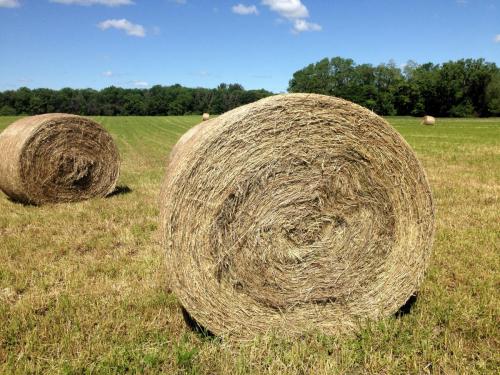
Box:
left=0, top=116, right=500, bottom=374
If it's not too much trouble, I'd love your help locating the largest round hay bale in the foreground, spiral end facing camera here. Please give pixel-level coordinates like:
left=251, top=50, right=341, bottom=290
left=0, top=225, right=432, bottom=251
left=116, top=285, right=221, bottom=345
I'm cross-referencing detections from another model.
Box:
left=160, top=94, right=434, bottom=340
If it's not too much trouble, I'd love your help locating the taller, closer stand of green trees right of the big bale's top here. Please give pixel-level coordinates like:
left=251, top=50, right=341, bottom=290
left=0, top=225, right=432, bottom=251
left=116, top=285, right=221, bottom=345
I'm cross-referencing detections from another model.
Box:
left=288, top=57, right=500, bottom=117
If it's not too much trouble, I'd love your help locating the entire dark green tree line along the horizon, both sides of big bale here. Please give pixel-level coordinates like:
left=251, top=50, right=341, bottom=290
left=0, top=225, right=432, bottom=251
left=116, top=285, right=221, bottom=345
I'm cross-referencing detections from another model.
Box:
left=0, top=57, right=500, bottom=117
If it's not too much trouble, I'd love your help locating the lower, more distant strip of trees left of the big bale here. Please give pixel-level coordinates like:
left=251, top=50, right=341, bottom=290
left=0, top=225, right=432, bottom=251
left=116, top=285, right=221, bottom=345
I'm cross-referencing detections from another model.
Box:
left=0, top=83, right=272, bottom=116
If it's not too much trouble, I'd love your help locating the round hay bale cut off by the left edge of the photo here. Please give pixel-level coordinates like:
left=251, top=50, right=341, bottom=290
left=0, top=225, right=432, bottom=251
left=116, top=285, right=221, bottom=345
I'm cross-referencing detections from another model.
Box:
left=0, top=113, right=120, bottom=204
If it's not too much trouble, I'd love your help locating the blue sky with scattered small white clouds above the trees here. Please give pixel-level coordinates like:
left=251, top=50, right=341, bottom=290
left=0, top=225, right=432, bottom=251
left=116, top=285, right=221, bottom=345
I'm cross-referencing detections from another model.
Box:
left=0, top=0, right=500, bottom=92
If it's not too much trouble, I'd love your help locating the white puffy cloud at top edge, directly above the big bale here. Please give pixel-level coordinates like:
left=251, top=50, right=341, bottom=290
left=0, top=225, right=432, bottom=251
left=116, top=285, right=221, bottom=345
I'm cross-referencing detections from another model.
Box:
left=262, top=0, right=322, bottom=34
